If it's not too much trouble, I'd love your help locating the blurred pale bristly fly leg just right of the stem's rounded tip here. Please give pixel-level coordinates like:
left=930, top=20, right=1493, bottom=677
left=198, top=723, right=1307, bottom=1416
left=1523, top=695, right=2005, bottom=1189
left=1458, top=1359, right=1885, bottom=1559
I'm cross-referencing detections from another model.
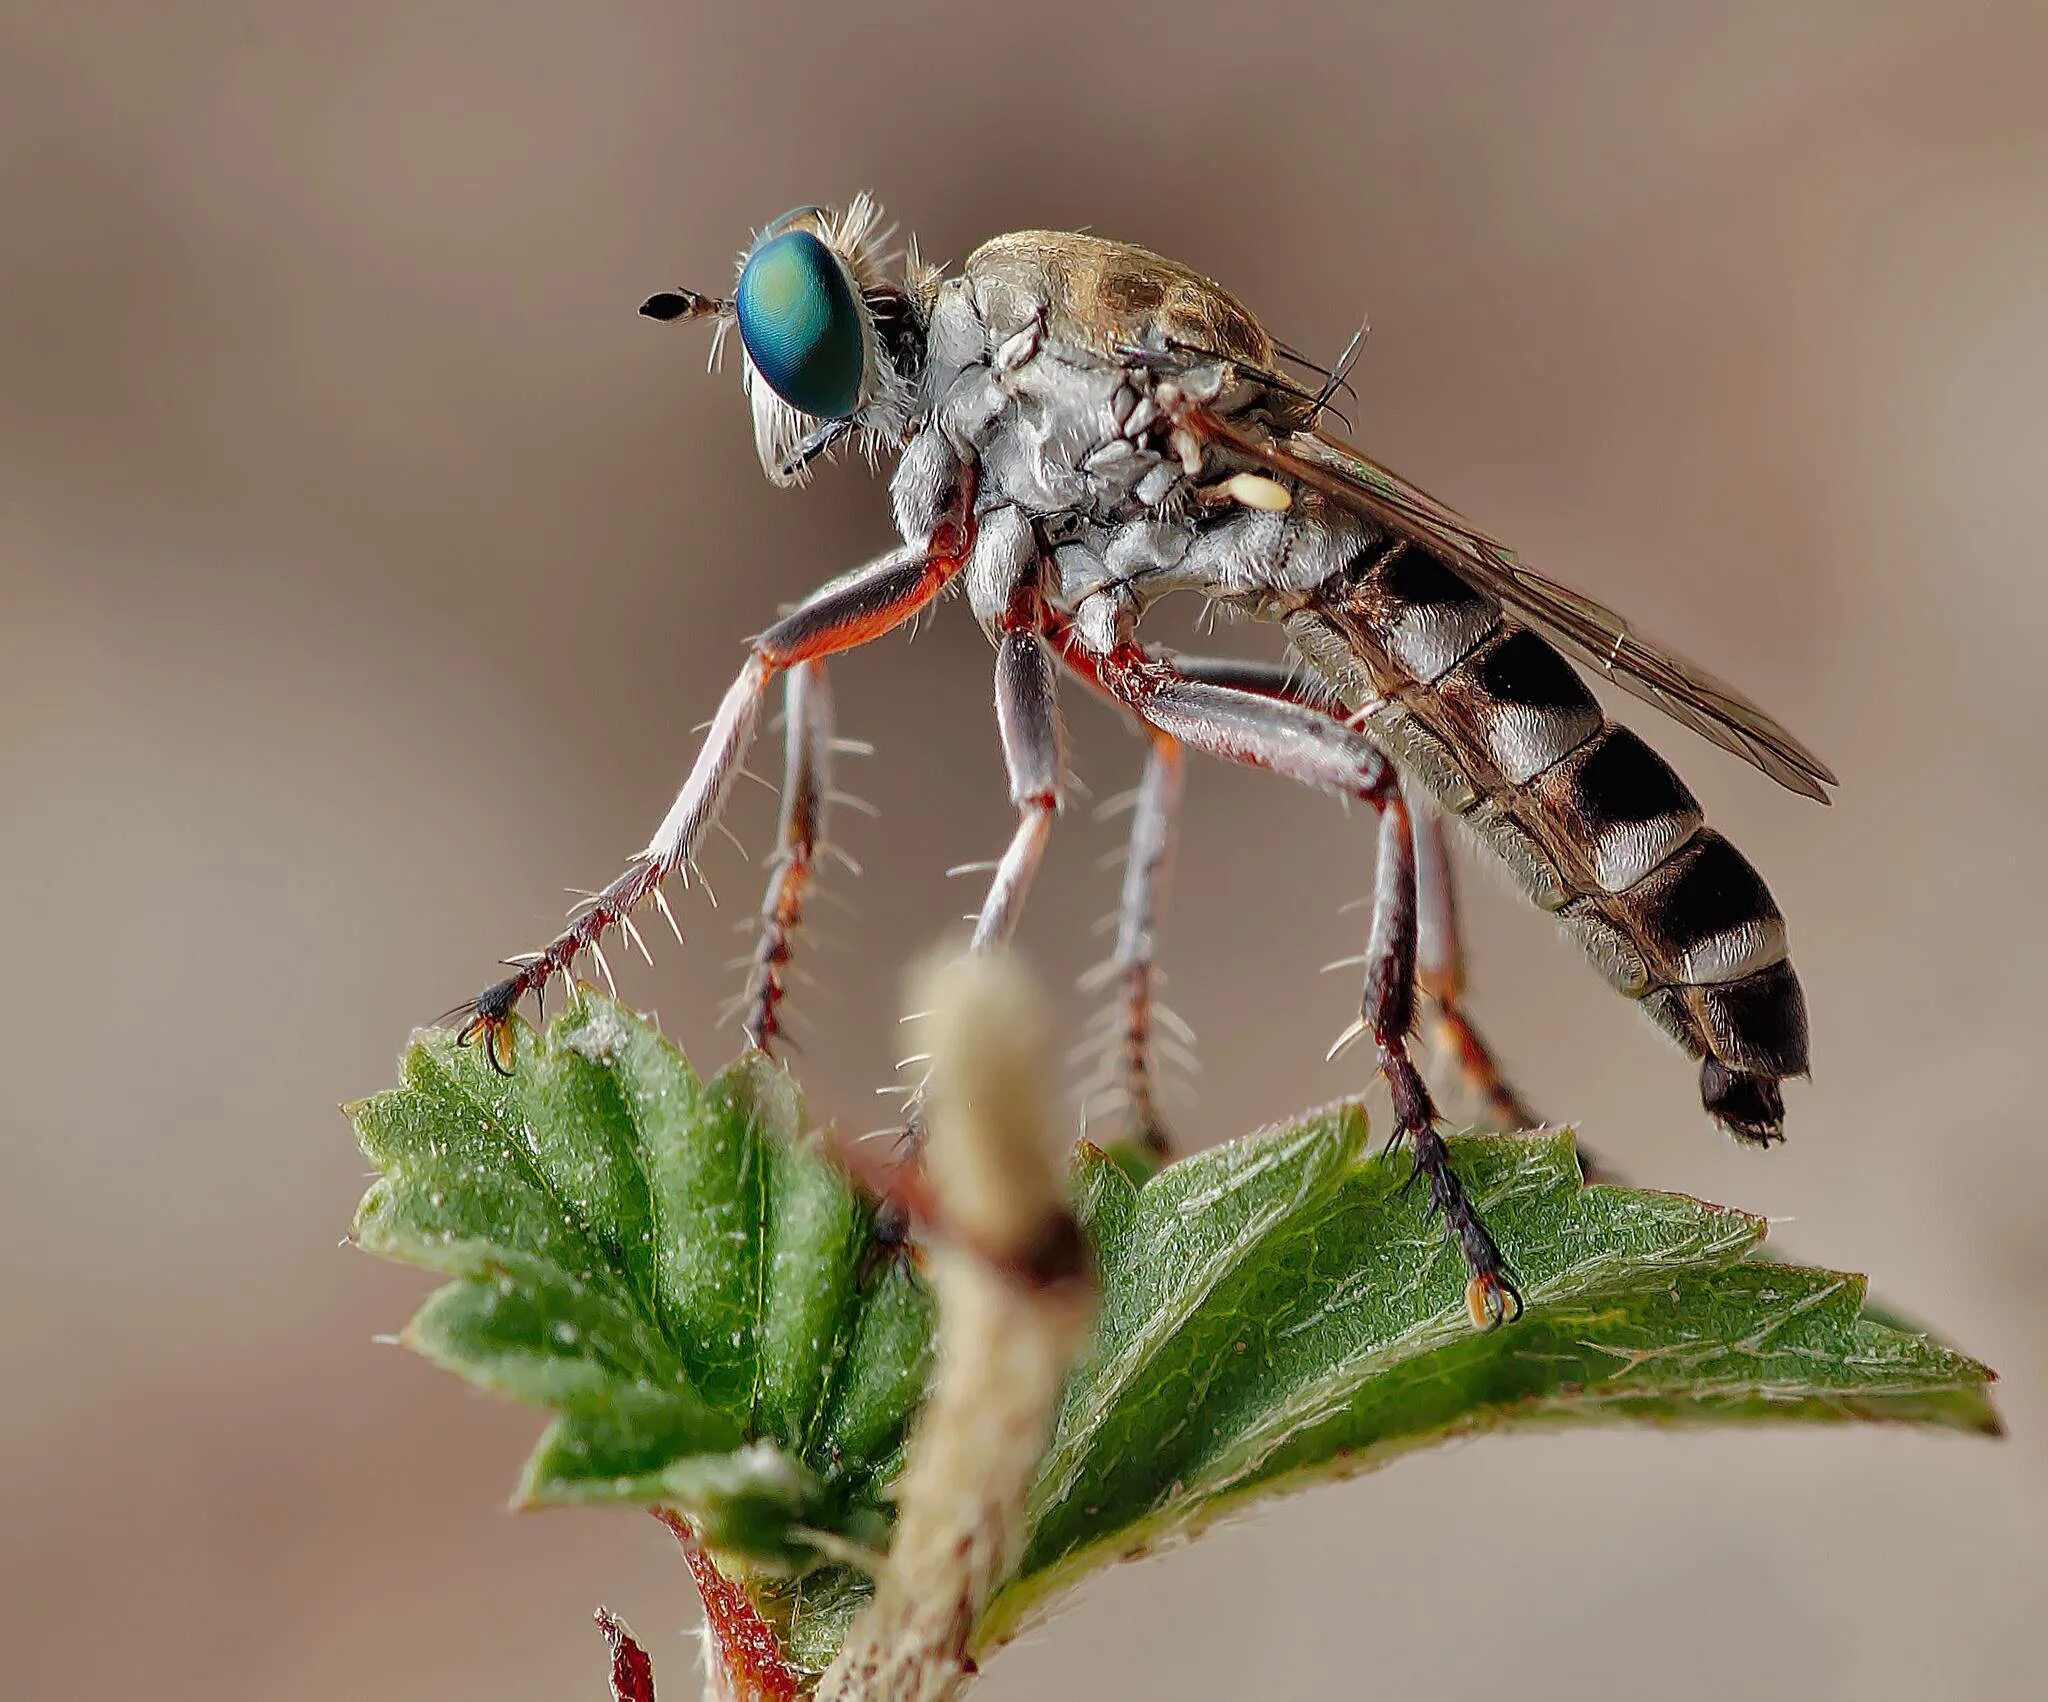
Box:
left=1081, top=729, right=1194, bottom=1161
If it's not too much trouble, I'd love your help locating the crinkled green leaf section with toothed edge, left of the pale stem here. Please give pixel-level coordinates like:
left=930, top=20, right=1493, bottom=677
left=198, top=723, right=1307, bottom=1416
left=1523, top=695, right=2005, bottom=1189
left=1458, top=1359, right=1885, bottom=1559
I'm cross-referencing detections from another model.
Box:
left=350, top=993, right=930, bottom=1577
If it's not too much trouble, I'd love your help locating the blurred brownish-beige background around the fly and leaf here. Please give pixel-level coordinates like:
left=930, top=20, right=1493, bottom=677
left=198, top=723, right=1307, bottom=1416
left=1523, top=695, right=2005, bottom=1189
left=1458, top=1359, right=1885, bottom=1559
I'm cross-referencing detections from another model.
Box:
left=0, top=0, right=2048, bottom=1702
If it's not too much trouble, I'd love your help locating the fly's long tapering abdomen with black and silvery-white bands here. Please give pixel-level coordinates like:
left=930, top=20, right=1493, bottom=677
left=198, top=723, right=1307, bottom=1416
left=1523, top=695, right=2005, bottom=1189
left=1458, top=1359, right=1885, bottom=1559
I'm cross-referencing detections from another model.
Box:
left=1286, top=539, right=1806, bottom=1141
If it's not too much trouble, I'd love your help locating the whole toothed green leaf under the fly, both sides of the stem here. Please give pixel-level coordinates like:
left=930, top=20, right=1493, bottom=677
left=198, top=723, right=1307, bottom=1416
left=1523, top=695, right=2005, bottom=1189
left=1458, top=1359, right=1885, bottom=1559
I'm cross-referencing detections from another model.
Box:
left=350, top=991, right=1997, bottom=1671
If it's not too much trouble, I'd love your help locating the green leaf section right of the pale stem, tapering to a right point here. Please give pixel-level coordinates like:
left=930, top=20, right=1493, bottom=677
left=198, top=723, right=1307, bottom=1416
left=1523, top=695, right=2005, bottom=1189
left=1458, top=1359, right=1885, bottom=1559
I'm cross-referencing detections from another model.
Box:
left=975, top=1106, right=1999, bottom=1649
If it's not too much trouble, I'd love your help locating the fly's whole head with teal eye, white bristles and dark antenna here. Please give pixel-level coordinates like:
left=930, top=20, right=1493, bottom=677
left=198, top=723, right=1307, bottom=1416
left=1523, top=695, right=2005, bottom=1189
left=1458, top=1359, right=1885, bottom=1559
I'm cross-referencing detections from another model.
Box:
left=641, top=195, right=924, bottom=485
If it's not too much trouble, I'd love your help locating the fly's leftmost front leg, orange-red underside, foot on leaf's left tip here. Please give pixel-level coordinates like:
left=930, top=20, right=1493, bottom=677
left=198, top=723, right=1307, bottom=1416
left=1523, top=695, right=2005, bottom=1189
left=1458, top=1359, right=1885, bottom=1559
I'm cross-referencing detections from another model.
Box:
left=449, top=532, right=969, bottom=1073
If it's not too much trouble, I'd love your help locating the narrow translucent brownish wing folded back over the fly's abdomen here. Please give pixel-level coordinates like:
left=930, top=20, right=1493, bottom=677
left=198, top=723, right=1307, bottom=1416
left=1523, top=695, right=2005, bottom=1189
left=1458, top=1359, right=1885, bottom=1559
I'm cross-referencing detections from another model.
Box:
left=1190, top=410, right=1839, bottom=803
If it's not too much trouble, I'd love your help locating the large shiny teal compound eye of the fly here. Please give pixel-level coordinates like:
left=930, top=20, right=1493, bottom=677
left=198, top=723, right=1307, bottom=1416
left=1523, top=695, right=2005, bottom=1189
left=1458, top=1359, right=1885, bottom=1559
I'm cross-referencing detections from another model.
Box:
left=733, top=231, right=866, bottom=420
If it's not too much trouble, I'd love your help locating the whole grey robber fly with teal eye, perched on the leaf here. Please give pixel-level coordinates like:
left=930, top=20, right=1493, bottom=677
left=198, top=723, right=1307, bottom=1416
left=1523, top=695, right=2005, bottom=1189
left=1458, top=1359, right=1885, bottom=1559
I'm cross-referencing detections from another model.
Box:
left=459, top=197, right=1835, bottom=1327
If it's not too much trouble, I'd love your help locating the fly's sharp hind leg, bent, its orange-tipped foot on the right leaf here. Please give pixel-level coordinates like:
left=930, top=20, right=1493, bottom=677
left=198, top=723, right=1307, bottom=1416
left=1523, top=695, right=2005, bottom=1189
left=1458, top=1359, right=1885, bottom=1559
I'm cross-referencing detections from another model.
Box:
left=1063, top=633, right=1522, bottom=1329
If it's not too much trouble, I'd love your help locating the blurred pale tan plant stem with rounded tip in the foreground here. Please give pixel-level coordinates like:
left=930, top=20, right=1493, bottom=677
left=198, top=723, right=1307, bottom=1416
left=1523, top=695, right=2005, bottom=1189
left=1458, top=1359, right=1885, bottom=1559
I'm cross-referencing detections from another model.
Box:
left=817, top=952, right=1094, bottom=1702
